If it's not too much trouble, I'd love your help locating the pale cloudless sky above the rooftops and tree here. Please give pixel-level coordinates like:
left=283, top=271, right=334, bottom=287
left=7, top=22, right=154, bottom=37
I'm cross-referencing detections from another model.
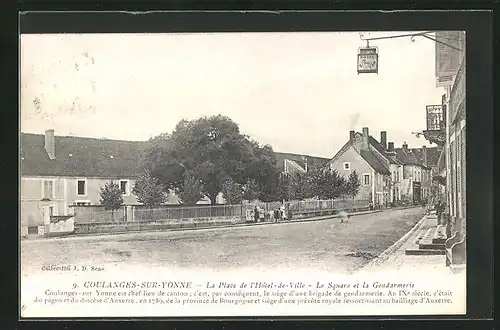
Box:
left=20, top=32, right=444, bottom=158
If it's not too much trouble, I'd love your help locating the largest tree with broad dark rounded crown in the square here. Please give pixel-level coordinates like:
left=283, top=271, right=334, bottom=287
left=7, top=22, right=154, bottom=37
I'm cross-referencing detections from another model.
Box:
left=142, top=115, right=282, bottom=204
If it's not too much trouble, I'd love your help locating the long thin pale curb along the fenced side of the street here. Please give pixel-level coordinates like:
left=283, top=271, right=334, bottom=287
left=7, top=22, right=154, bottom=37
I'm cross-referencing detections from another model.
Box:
left=21, top=207, right=424, bottom=245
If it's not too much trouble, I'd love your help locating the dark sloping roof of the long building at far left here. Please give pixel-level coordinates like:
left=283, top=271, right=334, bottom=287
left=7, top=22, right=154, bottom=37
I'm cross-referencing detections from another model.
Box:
left=20, top=133, right=143, bottom=178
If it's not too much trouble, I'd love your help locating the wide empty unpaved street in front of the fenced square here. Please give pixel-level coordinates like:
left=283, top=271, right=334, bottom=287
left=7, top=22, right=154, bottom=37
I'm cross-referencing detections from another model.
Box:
left=21, top=207, right=424, bottom=277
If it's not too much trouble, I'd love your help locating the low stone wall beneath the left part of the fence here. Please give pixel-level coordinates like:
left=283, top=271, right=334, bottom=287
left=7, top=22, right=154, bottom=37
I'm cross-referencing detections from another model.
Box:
left=74, top=216, right=242, bottom=234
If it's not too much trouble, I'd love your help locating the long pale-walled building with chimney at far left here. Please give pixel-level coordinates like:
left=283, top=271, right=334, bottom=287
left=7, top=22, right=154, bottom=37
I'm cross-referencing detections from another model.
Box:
left=20, top=130, right=147, bottom=227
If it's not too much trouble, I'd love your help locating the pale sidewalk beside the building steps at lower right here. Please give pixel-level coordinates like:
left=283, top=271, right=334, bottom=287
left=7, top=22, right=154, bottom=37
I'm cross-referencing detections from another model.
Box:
left=361, top=211, right=465, bottom=273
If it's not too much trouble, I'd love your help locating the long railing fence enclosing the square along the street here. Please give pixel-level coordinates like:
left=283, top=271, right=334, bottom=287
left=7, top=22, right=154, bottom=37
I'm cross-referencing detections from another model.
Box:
left=68, top=199, right=370, bottom=224
